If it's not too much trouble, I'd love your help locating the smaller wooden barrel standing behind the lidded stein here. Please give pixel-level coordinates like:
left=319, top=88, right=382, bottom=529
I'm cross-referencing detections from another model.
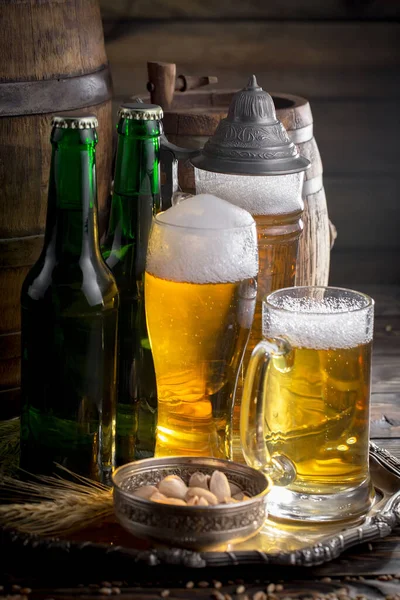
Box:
left=148, top=90, right=332, bottom=285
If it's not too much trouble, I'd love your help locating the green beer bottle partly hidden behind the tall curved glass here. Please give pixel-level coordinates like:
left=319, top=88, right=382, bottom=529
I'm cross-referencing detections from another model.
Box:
left=102, top=103, right=163, bottom=465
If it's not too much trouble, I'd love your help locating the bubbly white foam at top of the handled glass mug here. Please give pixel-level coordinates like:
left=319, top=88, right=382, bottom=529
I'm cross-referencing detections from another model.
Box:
left=263, top=287, right=374, bottom=350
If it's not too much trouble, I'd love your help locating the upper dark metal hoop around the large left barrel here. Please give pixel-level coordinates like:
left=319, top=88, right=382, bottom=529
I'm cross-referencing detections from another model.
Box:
left=0, top=65, right=112, bottom=117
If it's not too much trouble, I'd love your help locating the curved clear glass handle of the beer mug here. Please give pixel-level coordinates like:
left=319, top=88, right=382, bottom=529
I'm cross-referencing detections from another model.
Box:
left=240, top=338, right=296, bottom=486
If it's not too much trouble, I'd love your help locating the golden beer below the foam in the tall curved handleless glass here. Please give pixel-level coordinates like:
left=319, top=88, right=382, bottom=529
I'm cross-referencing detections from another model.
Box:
left=145, top=273, right=255, bottom=458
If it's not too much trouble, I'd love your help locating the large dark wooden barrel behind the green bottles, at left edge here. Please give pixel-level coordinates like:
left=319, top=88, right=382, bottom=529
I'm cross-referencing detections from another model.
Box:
left=0, top=0, right=112, bottom=419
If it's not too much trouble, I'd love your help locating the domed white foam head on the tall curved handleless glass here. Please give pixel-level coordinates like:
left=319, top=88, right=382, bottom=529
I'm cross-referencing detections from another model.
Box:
left=146, top=194, right=258, bottom=283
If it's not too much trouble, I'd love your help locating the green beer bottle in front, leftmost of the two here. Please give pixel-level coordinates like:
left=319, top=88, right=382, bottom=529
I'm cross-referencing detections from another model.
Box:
left=21, top=116, right=119, bottom=483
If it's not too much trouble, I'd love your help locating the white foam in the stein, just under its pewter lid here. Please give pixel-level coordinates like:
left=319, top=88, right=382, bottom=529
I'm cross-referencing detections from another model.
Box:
left=194, top=169, right=304, bottom=215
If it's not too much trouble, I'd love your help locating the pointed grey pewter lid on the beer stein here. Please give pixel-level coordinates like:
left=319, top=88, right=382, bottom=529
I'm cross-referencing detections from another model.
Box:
left=191, top=75, right=310, bottom=175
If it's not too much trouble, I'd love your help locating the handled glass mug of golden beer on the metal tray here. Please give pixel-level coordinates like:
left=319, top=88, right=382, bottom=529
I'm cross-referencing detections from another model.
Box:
left=240, top=287, right=374, bottom=521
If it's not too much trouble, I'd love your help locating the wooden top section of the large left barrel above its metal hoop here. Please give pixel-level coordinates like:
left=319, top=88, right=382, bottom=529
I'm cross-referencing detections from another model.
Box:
left=0, top=0, right=107, bottom=81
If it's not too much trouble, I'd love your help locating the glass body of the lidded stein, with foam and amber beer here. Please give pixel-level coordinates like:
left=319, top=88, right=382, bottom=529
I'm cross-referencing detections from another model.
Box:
left=195, top=169, right=304, bottom=461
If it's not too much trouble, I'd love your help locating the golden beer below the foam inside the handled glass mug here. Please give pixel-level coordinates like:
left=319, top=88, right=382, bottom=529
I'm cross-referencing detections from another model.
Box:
left=265, top=343, right=371, bottom=494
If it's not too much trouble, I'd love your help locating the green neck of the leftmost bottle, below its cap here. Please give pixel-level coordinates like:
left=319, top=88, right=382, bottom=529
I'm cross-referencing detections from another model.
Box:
left=45, top=129, right=100, bottom=262
